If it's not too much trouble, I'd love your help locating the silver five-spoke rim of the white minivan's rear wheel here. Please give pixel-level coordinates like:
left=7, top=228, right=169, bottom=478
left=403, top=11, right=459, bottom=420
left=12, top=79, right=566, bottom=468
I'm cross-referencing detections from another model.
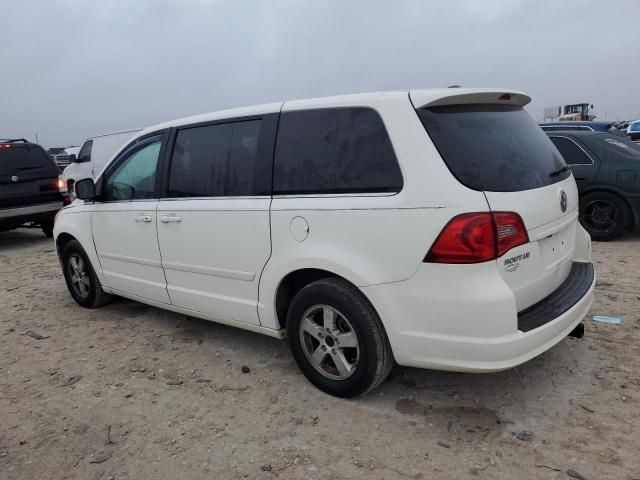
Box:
left=300, top=305, right=360, bottom=380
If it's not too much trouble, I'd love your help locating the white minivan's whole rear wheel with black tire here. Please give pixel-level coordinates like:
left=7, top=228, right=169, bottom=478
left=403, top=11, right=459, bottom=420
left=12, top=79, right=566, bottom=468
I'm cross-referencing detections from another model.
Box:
left=287, top=278, right=394, bottom=397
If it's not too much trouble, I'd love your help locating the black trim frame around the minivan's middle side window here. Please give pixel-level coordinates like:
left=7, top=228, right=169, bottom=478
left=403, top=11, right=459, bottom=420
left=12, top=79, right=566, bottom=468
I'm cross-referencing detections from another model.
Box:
left=159, top=111, right=280, bottom=201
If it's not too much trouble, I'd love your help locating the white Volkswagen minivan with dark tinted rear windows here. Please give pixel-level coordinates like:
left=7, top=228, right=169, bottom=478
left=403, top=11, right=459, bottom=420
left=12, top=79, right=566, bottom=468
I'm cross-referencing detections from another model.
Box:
left=55, top=89, right=595, bottom=397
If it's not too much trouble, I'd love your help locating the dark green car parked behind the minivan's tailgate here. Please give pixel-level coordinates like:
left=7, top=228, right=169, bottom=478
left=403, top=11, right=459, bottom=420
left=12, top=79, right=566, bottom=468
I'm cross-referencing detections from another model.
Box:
left=547, top=131, right=640, bottom=240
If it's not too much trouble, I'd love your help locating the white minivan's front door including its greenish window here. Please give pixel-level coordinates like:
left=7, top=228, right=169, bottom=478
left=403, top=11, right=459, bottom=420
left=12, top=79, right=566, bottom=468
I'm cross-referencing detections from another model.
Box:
left=91, top=135, right=170, bottom=303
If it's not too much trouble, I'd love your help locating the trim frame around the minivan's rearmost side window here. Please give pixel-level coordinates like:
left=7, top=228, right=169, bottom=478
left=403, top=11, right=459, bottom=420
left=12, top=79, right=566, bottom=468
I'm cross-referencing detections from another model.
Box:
left=271, top=105, right=405, bottom=199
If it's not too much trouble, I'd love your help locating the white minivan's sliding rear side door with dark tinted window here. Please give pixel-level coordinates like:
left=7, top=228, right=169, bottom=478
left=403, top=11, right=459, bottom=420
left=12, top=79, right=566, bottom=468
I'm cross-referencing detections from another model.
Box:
left=158, top=116, right=274, bottom=324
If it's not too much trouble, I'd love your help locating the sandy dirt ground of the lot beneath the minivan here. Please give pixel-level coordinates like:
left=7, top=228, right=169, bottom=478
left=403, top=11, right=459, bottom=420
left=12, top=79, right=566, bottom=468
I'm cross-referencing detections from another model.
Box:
left=0, top=230, right=640, bottom=480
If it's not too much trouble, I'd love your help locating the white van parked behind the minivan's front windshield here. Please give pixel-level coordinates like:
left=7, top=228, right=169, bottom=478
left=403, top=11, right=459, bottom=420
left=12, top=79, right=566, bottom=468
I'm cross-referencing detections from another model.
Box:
left=62, top=129, right=140, bottom=195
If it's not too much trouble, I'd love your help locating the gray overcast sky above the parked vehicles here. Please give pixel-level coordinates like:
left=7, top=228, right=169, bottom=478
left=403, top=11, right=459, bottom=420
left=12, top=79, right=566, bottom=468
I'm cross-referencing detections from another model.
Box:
left=0, top=0, right=640, bottom=147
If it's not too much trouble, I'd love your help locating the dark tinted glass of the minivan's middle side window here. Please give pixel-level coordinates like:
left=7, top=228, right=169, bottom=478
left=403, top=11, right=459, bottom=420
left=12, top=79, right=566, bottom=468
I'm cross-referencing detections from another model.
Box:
left=168, top=120, right=265, bottom=197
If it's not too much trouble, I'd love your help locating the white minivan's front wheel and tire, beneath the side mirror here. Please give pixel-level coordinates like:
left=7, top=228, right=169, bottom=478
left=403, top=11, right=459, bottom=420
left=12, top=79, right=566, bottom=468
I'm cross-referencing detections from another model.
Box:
left=62, top=240, right=111, bottom=308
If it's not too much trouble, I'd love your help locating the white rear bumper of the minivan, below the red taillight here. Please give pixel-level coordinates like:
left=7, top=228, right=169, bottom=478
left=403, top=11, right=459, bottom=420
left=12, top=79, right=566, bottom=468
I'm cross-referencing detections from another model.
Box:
left=363, top=262, right=595, bottom=372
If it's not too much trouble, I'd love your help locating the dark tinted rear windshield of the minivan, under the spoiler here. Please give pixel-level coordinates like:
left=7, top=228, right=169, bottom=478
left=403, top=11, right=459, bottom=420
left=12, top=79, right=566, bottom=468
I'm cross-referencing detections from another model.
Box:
left=418, top=104, right=571, bottom=192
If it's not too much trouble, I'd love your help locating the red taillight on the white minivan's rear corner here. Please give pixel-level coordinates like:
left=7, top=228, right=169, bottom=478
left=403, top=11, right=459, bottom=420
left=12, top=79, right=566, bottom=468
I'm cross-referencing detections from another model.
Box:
left=424, top=212, right=529, bottom=263
